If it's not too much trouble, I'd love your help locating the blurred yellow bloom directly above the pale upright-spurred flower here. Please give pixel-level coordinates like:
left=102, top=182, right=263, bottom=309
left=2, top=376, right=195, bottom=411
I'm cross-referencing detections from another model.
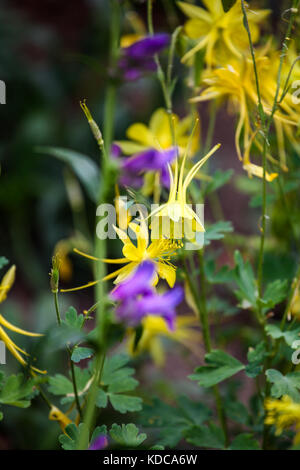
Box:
left=116, top=108, right=199, bottom=155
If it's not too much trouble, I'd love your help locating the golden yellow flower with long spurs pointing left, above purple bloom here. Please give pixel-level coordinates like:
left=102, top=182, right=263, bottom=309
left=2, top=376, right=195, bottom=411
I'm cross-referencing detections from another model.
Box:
left=61, top=217, right=179, bottom=292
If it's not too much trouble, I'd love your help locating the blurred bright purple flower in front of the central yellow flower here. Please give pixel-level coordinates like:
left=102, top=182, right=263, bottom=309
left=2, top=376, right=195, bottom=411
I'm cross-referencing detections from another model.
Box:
left=110, top=261, right=183, bottom=331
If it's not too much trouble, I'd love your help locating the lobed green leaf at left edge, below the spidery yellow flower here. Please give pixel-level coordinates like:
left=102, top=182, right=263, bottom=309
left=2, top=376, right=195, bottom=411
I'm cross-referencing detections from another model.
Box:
left=0, top=374, right=40, bottom=408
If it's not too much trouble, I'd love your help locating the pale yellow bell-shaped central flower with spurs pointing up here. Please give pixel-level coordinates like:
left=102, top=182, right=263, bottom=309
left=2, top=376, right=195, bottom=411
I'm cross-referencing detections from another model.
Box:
left=149, top=144, right=221, bottom=239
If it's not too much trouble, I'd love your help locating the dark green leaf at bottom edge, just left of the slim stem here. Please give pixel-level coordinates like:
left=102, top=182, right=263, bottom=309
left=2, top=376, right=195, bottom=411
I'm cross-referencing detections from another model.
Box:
left=185, top=423, right=225, bottom=449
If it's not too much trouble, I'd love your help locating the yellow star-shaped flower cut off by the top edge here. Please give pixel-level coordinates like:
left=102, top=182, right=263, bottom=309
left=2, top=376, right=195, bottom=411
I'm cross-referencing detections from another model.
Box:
left=178, top=0, right=270, bottom=66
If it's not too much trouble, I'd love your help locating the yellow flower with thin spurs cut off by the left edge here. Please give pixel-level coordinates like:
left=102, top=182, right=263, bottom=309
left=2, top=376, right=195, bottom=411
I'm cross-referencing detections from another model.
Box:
left=0, top=266, right=46, bottom=373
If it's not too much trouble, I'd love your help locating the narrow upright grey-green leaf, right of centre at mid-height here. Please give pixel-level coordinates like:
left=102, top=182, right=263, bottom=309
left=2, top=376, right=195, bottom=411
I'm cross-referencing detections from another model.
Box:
left=234, top=251, right=257, bottom=308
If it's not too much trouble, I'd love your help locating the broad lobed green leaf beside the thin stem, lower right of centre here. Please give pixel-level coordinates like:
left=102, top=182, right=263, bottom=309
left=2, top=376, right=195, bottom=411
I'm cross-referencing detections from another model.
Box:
left=189, top=350, right=245, bottom=387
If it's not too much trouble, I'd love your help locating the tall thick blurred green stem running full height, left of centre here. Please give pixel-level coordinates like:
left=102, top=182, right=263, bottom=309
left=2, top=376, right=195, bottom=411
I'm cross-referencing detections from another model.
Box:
left=78, top=0, right=120, bottom=450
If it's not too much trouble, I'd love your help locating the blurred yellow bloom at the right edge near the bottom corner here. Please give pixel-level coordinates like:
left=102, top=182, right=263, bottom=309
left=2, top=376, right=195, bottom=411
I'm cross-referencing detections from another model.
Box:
left=265, top=395, right=300, bottom=445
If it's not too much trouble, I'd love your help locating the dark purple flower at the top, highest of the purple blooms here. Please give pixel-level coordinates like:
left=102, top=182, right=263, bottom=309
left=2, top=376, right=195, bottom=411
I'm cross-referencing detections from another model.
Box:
left=119, top=33, right=170, bottom=81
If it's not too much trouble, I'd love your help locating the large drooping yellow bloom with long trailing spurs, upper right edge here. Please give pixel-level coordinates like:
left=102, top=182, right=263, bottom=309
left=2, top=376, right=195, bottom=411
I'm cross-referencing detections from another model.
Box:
left=191, top=50, right=299, bottom=176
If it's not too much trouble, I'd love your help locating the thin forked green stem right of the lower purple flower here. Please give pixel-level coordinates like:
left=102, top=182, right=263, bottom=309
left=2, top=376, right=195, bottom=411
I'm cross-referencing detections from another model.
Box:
left=183, top=250, right=229, bottom=447
